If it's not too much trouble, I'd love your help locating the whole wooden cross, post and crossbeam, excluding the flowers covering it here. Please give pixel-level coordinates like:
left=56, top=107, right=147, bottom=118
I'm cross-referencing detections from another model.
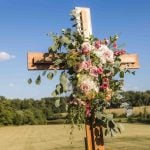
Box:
left=27, top=7, right=139, bottom=150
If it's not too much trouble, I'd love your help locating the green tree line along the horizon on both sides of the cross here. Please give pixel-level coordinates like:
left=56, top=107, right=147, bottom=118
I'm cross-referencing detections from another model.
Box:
left=0, top=91, right=150, bottom=125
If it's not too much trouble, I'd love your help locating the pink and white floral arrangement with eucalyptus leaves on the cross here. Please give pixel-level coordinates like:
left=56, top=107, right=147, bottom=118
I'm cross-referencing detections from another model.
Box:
left=29, top=9, right=133, bottom=135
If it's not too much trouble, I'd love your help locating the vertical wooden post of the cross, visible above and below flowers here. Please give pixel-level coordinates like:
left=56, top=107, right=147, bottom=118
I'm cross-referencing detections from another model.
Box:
left=75, top=7, right=104, bottom=150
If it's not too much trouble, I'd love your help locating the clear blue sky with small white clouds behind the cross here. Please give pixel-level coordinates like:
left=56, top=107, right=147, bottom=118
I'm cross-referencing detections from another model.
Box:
left=0, top=0, right=150, bottom=99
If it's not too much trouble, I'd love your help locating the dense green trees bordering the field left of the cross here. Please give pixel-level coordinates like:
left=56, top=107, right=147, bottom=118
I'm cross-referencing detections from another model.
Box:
left=0, top=96, right=66, bottom=125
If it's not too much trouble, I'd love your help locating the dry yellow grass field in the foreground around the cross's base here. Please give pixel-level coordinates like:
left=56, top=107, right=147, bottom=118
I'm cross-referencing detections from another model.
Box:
left=0, top=124, right=150, bottom=150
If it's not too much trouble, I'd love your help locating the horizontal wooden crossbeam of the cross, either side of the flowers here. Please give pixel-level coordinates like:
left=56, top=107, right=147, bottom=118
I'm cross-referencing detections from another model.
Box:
left=27, top=52, right=140, bottom=70
